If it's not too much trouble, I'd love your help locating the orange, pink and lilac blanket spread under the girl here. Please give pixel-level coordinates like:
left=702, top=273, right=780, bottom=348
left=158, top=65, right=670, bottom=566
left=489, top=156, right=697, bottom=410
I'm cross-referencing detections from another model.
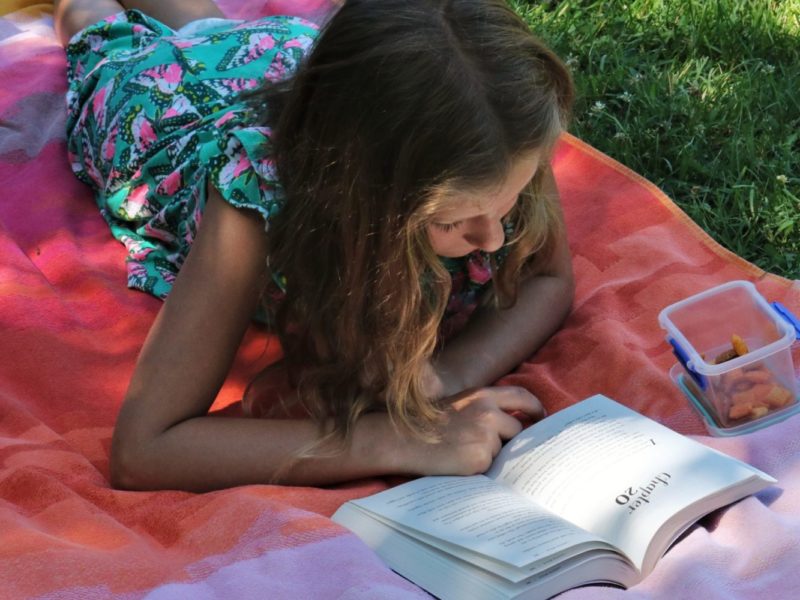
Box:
left=0, top=0, right=800, bottom=600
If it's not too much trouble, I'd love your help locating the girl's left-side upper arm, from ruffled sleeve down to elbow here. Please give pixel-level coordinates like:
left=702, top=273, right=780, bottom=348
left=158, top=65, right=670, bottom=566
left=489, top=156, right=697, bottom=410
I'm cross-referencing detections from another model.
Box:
left=115, top=190, right=266, bottom=448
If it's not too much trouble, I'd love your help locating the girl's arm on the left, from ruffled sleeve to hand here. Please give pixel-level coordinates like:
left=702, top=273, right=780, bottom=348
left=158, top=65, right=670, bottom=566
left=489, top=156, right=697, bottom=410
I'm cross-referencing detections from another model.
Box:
left=110, top=190, right=541, bottom=491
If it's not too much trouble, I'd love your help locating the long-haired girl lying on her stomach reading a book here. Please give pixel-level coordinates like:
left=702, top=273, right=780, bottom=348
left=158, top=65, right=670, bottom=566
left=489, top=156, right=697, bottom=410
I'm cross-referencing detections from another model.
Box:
left=55, top=0, right=573, bottom=490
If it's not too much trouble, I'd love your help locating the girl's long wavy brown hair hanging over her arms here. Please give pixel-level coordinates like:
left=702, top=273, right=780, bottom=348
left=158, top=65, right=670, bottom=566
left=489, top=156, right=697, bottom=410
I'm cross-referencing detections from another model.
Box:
left=242, top=0, right=573, bottom=446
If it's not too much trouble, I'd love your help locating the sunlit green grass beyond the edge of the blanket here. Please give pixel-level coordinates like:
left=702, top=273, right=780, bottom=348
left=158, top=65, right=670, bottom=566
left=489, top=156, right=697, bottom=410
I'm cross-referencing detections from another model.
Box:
left=514, top=0, right=800, bottom=279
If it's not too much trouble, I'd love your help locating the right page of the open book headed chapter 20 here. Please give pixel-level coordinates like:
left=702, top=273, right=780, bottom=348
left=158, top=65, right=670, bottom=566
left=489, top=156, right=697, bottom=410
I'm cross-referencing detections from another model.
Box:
left=487, top=396, right=774, bottom=568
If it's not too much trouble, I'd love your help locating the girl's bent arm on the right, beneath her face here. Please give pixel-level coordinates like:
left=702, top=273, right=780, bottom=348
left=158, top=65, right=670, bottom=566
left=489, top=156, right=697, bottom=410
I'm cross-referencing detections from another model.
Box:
left=432, top=168, right=575, bottom=397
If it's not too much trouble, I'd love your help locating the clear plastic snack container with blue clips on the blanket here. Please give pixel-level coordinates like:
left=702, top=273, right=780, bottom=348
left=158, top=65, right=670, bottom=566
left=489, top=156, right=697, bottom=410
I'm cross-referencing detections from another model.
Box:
left=658, top=281, right=800, bottom=436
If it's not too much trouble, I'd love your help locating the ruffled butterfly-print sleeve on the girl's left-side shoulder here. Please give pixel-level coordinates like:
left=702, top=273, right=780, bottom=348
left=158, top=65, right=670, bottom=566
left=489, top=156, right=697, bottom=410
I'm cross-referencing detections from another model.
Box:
left=200, top=112, right=283, bottom=229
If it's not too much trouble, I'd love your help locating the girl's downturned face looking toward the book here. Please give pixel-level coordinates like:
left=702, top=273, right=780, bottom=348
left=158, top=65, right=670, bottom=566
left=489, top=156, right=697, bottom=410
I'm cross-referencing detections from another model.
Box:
left=428, top=152, right=541, bottom=258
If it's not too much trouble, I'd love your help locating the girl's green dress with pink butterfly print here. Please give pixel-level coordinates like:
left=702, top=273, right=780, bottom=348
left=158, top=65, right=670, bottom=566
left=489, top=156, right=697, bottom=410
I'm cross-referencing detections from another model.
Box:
left=67, top=10, right=506, bottom=335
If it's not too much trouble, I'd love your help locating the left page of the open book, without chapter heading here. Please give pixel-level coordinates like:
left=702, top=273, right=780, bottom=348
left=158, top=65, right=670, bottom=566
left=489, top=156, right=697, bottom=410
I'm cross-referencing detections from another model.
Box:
left=352, top=475, right=604, bottom=568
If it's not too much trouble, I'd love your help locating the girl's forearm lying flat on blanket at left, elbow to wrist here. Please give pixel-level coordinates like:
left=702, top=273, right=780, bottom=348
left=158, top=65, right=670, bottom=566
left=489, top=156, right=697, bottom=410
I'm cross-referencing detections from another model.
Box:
left=111, top=413, right=417, bottom=492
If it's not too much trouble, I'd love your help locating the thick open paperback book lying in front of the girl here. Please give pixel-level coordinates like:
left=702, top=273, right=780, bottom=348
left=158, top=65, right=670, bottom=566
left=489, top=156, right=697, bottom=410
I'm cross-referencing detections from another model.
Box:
left=333, top=395, right=775, bottom=600
